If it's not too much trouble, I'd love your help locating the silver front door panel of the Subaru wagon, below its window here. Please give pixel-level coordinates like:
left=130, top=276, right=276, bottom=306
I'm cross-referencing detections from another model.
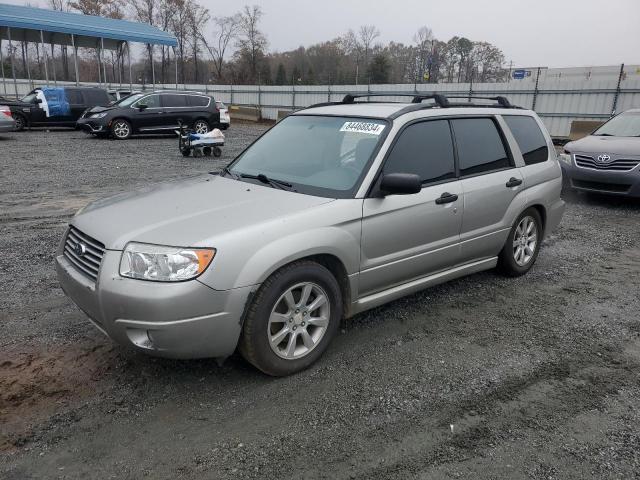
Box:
left=359, top=181, right=462, bottom=296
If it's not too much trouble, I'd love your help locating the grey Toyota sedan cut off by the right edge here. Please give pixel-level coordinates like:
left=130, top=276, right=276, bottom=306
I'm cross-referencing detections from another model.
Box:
left=560, top=109, right=640, bottom=198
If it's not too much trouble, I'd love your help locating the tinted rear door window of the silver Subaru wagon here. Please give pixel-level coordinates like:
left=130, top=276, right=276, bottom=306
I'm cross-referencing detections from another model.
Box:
left=451, top=118, right=511, bottom=176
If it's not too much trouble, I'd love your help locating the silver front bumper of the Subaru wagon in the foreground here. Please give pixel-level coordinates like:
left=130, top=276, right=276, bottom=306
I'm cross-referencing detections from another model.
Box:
left=56, top=246, right=252, bottom=359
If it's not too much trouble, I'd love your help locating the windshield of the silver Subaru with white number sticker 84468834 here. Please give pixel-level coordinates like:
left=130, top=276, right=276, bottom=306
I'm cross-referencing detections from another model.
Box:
left=229, top=115, right=387, bottom=198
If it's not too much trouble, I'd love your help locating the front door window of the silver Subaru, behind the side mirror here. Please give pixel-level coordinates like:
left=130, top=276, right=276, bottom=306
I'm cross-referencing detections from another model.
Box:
left=384, top=120, right=456, bottom=183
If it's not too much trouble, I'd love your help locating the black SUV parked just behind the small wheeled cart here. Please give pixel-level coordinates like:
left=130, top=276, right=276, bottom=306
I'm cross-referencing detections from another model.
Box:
left=78, top=90, right=228, bottom=140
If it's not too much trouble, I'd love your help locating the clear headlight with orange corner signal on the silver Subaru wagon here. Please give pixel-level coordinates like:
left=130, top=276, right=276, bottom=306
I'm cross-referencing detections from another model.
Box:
left=120, top=243, right=216, bottom=282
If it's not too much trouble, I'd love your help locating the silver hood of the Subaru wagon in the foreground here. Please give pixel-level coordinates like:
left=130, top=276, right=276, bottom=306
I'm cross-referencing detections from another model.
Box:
left=71, top=175, right=333, bottom=250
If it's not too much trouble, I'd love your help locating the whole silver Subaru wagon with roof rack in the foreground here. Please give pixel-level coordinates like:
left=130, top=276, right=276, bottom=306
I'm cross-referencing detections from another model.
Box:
left=56, top=96, right=564, bottom=375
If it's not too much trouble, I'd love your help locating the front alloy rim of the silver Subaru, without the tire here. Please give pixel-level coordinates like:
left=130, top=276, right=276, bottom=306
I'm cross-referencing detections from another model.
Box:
left=267, top=282, right=331, bottom=360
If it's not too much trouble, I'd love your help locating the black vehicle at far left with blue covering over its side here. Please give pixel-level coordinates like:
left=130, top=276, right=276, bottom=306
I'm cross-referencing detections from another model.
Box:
left=0, top=87, right=110, bottom=131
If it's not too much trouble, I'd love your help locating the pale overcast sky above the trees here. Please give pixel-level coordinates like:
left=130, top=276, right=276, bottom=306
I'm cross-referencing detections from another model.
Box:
left=0, top=0, right=640, bottom=67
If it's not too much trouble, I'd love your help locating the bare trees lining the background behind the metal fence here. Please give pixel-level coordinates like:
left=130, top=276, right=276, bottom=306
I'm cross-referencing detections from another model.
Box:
left=0, top=0, right=508, bottom=85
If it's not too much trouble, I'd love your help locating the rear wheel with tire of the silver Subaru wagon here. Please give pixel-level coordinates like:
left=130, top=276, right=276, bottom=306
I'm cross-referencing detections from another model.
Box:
left=498, top=208, right=543, bottom=277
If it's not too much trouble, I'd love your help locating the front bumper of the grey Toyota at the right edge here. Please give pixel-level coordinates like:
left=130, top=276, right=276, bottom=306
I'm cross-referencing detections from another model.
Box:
left=560, top=159, right=640, bottom=198
